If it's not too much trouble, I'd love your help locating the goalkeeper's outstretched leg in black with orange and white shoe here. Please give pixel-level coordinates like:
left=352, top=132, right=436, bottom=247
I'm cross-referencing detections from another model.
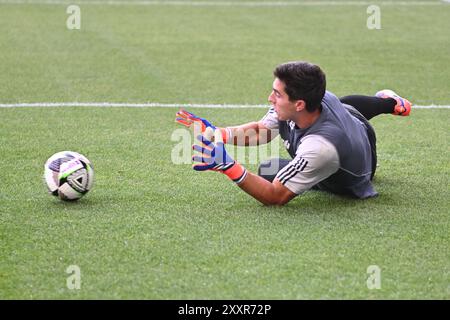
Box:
left=340, top=90, right=411, bottom=120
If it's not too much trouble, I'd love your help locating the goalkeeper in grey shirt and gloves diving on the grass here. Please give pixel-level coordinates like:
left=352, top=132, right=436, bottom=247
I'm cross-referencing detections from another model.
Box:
left=176, top=61, right=411, bottom=205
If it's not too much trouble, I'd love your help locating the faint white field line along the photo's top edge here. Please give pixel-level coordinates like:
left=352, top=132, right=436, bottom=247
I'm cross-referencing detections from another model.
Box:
left=0, top=0, right=444, bottom=7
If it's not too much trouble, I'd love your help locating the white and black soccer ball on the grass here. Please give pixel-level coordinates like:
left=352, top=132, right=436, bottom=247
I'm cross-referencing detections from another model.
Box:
left=44, top=151, right=94, bottom=201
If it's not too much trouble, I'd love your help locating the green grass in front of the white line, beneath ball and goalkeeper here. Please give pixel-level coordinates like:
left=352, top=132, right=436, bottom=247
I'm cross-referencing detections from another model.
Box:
left=0, top=108, right=450, bottom=299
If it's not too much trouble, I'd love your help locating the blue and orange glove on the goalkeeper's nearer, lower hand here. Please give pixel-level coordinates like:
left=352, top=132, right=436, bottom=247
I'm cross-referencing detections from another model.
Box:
left=192, top=129, right=247, bottom=184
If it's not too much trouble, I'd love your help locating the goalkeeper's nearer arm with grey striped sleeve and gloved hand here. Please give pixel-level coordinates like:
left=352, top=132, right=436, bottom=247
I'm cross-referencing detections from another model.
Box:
left=193, top=129, right=339, bottom=205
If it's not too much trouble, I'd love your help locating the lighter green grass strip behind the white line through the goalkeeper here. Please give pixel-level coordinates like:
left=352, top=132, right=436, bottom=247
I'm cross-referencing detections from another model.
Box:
left=0, top=6, right=450, bottom=105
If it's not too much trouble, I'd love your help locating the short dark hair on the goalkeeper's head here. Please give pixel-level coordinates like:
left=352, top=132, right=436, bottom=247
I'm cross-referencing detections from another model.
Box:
left=273, top=61, right=326, bottom=112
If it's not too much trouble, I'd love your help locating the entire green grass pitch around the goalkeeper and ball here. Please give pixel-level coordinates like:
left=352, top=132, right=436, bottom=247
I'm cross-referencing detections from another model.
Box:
left=0, top=1, right=450, bottom=299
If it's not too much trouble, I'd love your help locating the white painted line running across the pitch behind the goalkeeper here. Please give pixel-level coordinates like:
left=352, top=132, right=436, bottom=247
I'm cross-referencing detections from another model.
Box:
left=0, top=102, right=450, bottom=109
